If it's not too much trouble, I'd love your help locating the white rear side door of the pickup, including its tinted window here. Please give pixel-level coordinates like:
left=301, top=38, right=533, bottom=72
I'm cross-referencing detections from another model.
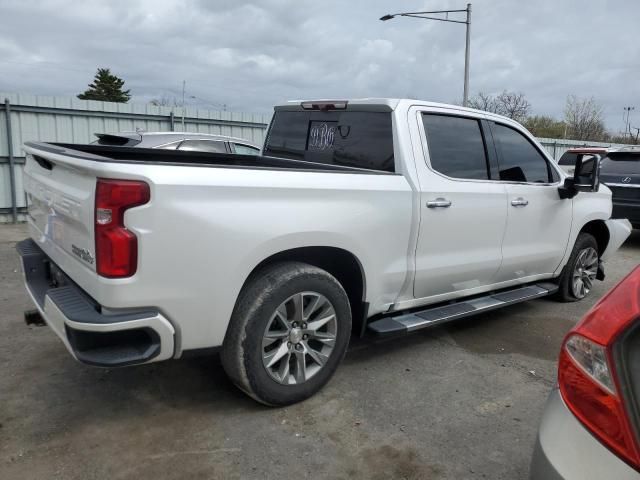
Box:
left=414, top=110, right=507, bottom=298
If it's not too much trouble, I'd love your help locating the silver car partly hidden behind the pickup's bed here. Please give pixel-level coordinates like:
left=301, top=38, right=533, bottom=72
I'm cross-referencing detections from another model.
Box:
left=93, top=132, right=260, bottom=155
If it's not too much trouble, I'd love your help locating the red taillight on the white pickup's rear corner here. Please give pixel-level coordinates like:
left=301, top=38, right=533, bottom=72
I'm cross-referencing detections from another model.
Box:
left=95, top=178, right=150, bottom=278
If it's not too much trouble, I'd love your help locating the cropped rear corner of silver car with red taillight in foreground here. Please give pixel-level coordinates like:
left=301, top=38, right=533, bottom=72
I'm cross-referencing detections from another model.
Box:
left=530, top=266, right=640, bottom=480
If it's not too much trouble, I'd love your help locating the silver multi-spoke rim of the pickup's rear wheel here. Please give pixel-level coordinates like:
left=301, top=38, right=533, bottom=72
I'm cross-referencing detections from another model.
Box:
left=262, top=292, right=338, bottom=385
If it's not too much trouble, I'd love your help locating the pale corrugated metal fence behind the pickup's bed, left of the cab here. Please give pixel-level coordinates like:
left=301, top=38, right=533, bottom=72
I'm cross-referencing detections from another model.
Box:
left=0, top=93, right=271, bottom=223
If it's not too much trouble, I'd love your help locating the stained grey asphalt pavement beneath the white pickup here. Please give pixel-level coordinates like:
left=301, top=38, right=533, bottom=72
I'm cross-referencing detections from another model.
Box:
left=0, top=225, right=640, bottom=480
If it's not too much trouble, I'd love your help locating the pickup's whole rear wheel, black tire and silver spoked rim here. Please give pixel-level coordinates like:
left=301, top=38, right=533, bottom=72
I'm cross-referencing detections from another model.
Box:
left=222, top=262, right=351, bottom=405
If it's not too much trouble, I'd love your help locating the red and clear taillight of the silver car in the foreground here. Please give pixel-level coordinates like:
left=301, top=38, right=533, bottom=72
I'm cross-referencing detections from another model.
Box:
left=558, top=267, right=640, bottom=469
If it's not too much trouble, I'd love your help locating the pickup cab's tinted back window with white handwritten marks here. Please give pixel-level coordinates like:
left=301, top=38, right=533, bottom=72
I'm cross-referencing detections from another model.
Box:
left=263, top=110, right=395, bottom=172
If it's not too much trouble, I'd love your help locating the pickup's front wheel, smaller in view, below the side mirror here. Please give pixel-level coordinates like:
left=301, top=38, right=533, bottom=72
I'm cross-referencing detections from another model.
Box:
left=558, top=233, right=600, bottom=302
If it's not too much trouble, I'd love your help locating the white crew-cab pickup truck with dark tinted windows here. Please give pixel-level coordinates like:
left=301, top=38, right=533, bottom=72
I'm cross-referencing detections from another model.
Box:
left=17, top=99, right=631, bottom=405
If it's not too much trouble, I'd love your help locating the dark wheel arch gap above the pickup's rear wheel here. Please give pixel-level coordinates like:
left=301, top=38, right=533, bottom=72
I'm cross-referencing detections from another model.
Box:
left=241, top=246, right=368, bottom=334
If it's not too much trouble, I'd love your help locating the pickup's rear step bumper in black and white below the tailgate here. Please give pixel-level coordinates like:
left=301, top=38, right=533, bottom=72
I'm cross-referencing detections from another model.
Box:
left=16, top=239, right=175, bottom=367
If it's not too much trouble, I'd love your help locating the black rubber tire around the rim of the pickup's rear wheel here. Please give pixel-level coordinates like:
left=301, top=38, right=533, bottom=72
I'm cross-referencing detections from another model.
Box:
left=221, top=262, right=351, bottom=406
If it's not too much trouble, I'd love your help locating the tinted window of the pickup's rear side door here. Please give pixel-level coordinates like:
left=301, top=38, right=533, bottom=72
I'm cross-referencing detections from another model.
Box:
left=422, top=113, right=489, bottom=180
